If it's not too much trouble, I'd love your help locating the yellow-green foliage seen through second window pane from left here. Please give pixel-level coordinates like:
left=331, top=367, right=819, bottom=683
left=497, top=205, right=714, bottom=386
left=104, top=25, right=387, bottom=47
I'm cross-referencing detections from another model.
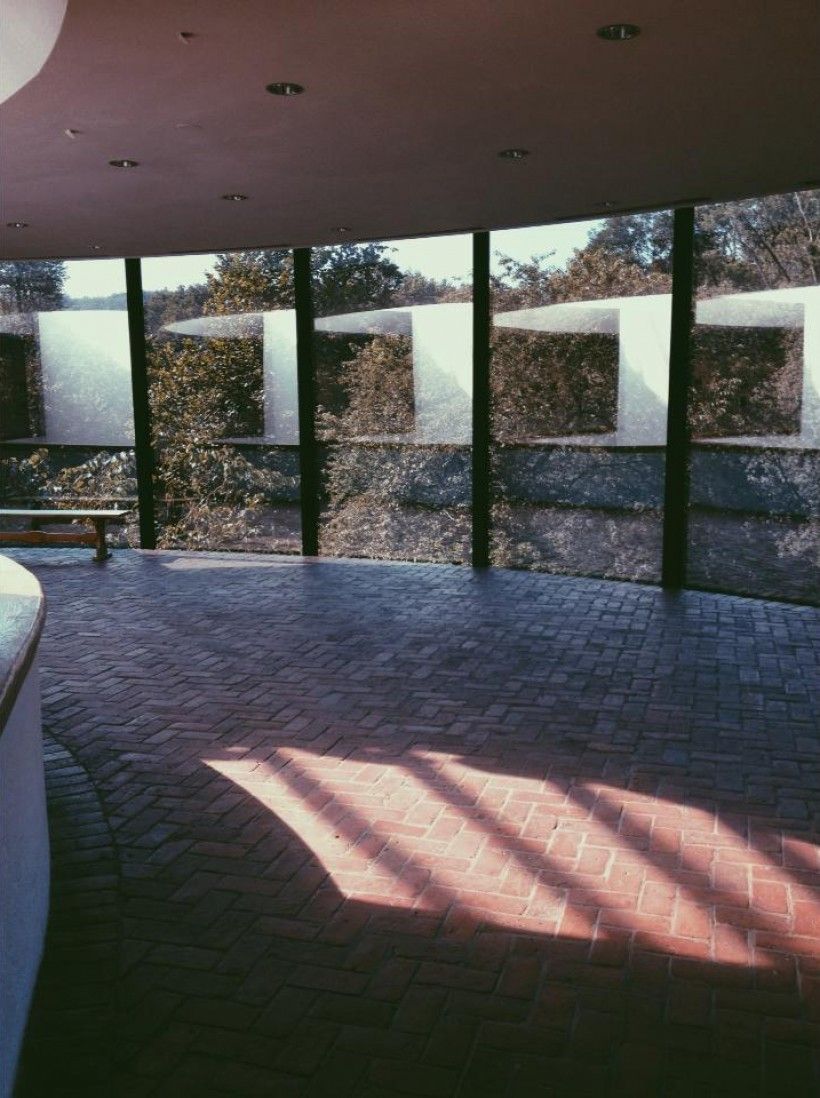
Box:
left=146, top=249, right=305, bottom=548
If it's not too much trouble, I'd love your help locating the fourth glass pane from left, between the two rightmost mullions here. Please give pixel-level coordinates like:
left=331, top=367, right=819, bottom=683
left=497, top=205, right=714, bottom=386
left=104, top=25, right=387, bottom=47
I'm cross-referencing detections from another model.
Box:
left=491, top=212, right=672, bottom=582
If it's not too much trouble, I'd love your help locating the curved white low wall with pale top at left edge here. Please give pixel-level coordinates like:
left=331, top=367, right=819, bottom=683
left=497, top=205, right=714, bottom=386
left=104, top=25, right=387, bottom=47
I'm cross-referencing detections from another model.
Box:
left=0, top=557, right=49, bottom=1098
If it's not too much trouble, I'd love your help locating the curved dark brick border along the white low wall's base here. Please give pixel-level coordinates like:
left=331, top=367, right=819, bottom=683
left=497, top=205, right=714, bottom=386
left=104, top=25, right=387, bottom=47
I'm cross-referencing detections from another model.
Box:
left=14, top=735, right=122, bottom=1098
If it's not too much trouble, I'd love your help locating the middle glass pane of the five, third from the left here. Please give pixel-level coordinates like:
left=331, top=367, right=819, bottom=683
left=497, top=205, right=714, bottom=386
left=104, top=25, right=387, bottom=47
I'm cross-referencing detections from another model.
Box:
left=313, top=236, right=472, bottom=561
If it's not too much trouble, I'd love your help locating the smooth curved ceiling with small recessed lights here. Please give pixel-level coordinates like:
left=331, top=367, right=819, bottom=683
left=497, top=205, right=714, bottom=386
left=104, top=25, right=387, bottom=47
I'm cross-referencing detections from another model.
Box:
left=0, top=0, right=820, bottom=258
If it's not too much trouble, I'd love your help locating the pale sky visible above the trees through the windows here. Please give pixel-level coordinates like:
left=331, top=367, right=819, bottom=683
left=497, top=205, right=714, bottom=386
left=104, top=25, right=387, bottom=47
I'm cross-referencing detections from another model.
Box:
left=65, top=221, right=600, bottom=298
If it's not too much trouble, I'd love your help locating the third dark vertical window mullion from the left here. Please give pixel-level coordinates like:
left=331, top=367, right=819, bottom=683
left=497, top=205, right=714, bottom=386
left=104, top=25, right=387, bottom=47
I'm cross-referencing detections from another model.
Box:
left=472, top=232, right=490, bottom=568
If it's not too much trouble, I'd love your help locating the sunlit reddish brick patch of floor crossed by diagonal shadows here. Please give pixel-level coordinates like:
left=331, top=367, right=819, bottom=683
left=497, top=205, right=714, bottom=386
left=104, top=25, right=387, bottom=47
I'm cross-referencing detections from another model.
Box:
left=203, top=747, right=820, bottom=970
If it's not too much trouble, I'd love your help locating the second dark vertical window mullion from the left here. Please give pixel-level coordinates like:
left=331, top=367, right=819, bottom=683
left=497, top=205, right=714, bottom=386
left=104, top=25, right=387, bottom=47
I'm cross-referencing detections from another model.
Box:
left=293, top=248, right=319, bottom=557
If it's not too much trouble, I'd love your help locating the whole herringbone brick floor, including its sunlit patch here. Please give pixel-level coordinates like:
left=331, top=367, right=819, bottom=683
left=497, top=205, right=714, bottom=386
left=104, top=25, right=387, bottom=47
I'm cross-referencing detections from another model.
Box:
left=11, top=550, right=820, bottom=1098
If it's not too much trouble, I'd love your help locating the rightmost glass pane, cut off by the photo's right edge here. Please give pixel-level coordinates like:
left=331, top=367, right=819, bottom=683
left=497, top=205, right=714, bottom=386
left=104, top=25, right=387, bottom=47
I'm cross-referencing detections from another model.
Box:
left=688, top=191, right=820, bottom=602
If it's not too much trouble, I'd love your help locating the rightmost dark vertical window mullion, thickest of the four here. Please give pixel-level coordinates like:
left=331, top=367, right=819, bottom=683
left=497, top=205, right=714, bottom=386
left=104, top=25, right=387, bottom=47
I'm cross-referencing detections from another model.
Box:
left=662, top=206, right=695, bottom=591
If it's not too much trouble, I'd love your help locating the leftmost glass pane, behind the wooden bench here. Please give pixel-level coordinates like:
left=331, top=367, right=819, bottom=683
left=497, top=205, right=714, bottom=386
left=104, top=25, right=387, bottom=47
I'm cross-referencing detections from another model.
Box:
left=0, top=259, right=139, bottom=545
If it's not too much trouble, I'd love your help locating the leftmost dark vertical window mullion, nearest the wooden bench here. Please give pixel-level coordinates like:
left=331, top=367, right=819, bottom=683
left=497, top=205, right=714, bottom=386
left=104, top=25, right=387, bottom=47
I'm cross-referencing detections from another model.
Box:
left=125, top=258, right=157, bottom=549
